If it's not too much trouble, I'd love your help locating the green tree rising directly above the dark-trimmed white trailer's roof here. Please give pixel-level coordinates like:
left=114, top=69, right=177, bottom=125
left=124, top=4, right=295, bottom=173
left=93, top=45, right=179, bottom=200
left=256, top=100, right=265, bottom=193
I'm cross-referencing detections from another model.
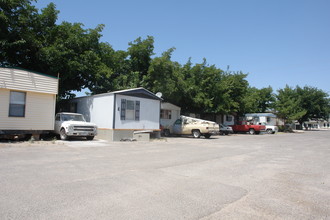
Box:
left=90, top=36, right=154, bottom=94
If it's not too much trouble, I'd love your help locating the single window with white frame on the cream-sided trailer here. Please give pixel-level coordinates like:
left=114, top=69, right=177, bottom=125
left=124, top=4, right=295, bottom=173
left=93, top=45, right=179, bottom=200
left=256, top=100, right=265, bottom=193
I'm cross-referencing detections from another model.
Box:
left=9, top=91, right=26, bottom=117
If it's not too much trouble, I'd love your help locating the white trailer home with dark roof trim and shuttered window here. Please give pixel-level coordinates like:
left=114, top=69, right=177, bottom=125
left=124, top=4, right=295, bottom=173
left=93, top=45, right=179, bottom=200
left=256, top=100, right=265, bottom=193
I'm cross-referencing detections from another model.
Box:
left=70, top=88, right=162, bottom=141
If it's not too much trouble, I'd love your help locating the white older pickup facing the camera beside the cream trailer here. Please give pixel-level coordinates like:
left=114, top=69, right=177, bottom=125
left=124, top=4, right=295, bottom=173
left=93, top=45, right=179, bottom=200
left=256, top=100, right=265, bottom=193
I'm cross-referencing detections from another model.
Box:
left=54, top=112, right=97, bottom=140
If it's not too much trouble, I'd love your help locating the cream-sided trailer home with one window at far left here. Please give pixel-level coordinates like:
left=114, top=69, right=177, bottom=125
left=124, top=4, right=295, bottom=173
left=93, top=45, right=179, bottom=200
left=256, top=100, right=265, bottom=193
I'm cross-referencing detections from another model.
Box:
left=0, top=68, right=58, bottom=138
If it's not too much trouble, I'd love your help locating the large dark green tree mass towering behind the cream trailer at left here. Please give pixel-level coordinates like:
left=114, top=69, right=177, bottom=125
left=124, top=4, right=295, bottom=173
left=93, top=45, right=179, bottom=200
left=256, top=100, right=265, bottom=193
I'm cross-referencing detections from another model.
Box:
left=0, top=0, right=112, bottom=97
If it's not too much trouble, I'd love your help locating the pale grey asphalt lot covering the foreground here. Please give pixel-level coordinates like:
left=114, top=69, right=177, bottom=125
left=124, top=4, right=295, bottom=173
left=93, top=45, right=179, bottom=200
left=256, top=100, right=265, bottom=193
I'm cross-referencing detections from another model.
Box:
left=0, top=131, right=330, bottom=220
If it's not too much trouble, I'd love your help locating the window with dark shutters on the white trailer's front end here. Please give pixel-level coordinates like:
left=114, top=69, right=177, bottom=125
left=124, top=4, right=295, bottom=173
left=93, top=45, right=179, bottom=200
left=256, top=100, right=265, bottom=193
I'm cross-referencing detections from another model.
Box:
left=120, top=99, right=140, bottom=121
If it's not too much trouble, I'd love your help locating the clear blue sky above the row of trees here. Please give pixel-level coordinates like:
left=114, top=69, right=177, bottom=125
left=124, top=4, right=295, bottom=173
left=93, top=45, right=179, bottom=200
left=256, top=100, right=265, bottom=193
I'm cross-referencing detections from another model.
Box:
left=36, top=0, right=330, bottom=93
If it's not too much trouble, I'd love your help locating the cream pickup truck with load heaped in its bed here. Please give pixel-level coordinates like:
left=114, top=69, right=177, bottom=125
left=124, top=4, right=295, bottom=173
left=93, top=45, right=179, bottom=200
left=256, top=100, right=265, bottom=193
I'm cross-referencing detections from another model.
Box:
left=163, top=115, right=219, bottom=138
